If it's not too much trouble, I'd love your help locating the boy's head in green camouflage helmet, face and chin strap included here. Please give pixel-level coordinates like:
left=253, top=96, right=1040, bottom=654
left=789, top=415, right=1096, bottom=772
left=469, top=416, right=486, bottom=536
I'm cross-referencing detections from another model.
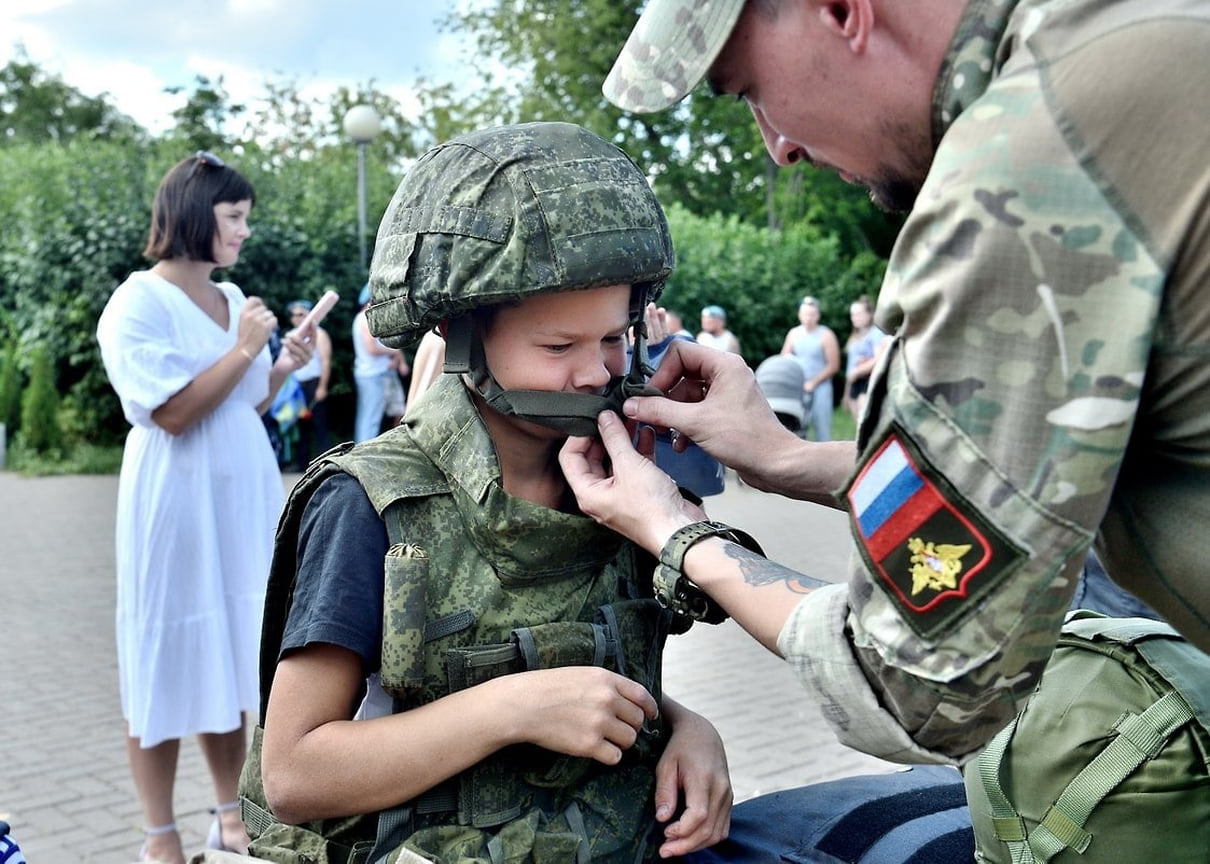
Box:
left=368, top=123, right=674, bottom=434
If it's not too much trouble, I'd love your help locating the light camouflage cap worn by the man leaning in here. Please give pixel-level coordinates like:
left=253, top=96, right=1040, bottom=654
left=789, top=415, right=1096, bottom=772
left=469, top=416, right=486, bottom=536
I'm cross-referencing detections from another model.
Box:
left=601, top=0, right=744, bottom=113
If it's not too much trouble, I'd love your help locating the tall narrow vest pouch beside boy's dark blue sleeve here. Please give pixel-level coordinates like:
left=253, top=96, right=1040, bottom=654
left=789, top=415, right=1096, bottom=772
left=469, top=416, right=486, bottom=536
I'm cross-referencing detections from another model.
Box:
left=381, top=543, right=428, bottom=701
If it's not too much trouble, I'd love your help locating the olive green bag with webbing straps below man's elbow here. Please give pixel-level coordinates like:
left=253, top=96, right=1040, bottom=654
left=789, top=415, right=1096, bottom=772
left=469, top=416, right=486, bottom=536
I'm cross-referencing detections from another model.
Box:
left=963, top=611, right=1210, bottom=864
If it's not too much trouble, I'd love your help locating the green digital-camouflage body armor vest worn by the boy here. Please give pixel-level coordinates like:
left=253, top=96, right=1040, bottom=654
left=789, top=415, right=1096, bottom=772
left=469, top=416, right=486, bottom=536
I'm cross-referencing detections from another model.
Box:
left=241, top=376, right=670, bottom=864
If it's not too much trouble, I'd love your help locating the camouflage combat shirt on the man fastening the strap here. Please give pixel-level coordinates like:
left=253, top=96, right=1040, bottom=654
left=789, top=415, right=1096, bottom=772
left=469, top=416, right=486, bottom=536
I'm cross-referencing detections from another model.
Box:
left=779, top=0, right=1210, bottom=762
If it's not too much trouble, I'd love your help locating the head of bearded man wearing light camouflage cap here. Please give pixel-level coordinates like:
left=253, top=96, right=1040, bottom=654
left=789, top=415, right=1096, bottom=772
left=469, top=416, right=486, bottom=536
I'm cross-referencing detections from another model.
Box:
left=603, top=0, right=966, bottom=209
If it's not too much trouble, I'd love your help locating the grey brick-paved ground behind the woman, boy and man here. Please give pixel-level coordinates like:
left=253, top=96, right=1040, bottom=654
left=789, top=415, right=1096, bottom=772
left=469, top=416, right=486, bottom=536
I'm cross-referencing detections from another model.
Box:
left=0, top=472, right=893, bottom=864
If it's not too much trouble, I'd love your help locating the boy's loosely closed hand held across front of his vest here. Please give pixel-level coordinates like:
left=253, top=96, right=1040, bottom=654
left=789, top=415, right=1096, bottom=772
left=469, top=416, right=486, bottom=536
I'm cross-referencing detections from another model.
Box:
left=515, top=666, right=659, bottom=765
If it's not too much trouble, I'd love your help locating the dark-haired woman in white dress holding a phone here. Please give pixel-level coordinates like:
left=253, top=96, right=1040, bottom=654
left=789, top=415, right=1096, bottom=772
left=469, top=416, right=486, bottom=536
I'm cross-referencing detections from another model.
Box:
left=97, top=152, right=315, bottom=864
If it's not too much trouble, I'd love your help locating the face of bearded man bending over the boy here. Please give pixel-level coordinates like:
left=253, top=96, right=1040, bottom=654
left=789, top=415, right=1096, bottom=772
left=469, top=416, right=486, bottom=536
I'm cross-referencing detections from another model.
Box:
left=709, top=2, right=933, bottom=211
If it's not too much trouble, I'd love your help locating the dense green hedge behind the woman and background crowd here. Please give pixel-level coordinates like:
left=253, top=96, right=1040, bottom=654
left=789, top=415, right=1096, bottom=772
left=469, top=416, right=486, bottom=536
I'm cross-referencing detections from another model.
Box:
left=0, top=140, right=885, bottom=447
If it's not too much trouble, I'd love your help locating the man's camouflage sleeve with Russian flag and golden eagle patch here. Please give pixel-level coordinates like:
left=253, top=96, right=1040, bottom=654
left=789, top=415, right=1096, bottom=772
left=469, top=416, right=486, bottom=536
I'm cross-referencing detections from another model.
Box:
left=779, top=2, right=1185, bottom=762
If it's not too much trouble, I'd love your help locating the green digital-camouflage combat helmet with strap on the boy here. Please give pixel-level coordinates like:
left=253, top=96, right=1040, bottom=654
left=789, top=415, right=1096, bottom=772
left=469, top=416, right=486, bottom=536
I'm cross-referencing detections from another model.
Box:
left=367, top=123, right=674, bottom=434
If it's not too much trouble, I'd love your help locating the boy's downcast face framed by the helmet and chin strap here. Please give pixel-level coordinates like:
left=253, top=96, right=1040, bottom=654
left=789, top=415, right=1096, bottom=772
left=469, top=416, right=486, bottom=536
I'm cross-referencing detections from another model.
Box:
left=483, top=284, right=630, bottom=394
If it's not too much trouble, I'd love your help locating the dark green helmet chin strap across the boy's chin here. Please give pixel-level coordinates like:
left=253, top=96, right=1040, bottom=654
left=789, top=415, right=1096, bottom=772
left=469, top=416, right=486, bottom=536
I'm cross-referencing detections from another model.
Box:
left=443, top=301, right=663, bottom=437
